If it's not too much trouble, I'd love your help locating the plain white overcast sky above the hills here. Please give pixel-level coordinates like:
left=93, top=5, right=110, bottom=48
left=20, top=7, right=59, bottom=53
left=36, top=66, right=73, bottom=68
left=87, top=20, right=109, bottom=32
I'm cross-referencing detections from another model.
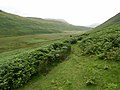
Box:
left=0, top=0, right=120, bottom=26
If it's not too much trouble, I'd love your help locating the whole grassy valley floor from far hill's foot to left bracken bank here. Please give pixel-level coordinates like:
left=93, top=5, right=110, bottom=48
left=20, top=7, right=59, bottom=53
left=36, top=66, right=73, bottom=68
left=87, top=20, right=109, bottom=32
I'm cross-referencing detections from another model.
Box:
left=0, top=32, right=83, bottom=63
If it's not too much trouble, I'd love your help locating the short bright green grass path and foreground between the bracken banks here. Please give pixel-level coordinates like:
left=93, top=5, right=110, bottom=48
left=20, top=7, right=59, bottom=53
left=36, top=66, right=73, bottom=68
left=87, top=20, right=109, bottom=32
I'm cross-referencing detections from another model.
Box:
left=18, top=44, right=120, bottom=90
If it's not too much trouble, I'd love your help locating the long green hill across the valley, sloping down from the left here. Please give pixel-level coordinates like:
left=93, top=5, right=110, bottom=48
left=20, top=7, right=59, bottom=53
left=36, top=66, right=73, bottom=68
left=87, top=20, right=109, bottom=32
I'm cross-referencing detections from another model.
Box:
left=0, top=10, right=90, bottom=37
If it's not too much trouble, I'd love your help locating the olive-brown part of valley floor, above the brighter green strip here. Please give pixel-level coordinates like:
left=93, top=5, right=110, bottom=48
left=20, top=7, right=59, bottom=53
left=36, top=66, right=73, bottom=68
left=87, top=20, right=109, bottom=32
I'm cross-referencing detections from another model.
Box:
left=0, top=32, right=79, bottom=53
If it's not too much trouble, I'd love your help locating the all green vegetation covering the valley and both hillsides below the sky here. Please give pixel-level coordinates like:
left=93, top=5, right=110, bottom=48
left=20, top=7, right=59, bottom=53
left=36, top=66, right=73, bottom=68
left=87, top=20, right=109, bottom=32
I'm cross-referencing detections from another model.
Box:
left=0, top=11, right=120, bottom=90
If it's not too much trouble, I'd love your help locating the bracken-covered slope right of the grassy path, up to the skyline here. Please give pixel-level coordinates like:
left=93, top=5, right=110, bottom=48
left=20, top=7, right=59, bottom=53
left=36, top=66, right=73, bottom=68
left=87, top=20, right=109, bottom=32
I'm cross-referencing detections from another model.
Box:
left=79, top=14, right=120, bottom=61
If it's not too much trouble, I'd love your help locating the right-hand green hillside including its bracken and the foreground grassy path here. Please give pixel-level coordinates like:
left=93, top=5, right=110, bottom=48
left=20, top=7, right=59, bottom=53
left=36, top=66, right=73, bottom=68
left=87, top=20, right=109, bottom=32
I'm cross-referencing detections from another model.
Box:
left=18, top=14, right=120, bottom=90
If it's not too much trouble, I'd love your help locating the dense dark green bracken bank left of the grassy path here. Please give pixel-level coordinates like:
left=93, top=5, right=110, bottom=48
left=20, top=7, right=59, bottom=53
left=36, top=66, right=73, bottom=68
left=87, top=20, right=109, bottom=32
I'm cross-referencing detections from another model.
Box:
left=0, top=42, right=71, bottom=90
